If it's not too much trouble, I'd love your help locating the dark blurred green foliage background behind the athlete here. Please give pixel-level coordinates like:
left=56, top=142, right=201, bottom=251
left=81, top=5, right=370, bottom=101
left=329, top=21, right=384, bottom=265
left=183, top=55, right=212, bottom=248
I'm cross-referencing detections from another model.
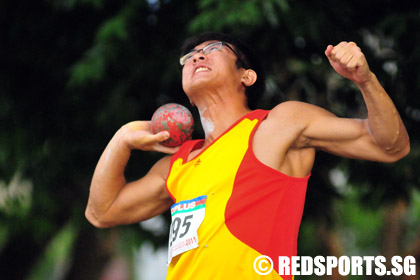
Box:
left=0, top=0, right=420, bottom=280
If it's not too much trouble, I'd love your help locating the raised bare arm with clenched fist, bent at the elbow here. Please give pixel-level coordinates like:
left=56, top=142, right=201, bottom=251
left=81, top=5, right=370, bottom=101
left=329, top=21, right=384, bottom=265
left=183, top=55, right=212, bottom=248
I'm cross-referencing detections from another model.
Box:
left=302, top=42, right=410, bottom=162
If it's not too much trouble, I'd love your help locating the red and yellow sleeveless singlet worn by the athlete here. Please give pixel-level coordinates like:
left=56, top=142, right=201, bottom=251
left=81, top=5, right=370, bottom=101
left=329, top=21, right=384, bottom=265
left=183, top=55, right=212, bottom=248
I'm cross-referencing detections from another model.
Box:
left=166, top=110, right=309, bottom=280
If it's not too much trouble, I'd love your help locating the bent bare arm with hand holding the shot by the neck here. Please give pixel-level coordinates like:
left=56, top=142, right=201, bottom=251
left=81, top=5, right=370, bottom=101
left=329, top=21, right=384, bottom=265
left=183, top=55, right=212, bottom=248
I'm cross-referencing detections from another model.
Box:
left=85, top=122, right=176, bottom=227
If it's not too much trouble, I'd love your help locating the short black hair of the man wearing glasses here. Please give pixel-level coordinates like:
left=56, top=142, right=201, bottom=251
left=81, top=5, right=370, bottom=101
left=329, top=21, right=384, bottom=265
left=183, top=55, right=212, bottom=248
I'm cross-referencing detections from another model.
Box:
left=181, top=32, right=265, bottom=109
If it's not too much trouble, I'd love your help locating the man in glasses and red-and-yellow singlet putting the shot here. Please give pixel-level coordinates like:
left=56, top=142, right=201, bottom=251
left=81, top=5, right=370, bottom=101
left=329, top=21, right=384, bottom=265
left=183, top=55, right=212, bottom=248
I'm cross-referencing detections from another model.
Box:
left=86, top=33, right=410, bottom=280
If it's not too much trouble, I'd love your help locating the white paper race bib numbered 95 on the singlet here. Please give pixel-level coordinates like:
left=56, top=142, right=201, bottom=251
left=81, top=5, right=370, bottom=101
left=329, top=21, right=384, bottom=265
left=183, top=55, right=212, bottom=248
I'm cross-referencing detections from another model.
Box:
left=168, top=195, right=207, bottom=265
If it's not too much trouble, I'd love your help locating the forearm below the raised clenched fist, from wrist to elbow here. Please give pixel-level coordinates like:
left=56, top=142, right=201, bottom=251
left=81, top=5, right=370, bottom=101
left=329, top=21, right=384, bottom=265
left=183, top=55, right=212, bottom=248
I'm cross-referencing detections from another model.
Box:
left=358, top=73, right=409, bottom=153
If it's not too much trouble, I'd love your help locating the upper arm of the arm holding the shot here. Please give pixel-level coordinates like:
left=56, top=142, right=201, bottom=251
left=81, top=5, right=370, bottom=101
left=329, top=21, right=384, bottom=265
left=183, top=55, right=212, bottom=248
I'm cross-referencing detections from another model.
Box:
left=99, top=157, right=173, bottom=224
